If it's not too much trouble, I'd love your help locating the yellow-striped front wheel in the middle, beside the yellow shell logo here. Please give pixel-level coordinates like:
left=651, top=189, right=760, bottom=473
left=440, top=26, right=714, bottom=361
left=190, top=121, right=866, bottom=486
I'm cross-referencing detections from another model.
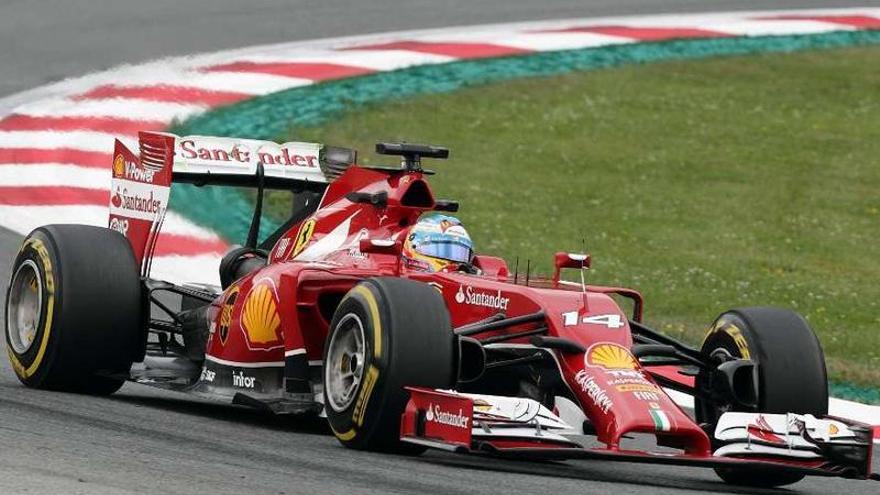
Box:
left=324, top=278, right=456, bottom=454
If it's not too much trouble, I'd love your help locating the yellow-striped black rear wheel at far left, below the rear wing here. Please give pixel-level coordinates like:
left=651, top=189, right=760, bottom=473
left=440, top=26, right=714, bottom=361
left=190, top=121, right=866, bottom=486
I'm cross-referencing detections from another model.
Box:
left=6, top=225, right=143, bottom=395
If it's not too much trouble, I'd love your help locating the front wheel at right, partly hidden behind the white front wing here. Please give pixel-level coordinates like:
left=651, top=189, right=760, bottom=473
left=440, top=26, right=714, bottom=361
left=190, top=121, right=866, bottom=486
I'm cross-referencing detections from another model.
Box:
left=696, top=307, right=828, bottom=487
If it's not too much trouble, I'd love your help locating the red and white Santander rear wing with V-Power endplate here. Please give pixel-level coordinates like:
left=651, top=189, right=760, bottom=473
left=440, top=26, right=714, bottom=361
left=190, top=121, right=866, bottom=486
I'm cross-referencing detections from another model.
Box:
left=109, top=132, right=357, bottom=276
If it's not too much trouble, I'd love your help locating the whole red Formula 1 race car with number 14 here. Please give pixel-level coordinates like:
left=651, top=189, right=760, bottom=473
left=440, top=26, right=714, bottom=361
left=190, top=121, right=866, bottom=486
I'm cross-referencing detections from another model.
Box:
left=6, top=133, right=877, bottom=486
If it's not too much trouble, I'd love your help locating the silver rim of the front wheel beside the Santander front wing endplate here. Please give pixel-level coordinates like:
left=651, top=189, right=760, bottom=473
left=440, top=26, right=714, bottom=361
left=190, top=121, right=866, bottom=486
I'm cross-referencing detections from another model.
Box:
left=324, top=313, right=367, bottom=412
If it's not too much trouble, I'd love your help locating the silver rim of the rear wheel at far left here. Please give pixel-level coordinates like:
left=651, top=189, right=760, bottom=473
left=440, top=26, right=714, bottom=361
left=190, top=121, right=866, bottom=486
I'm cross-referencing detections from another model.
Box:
left=6, top=260, right=43, bottom=355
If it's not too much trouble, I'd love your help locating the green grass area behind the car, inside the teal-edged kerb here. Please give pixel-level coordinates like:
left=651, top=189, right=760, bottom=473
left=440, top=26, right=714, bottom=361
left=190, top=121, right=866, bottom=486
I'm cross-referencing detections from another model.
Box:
left=278, top=48, right=880, bottom=386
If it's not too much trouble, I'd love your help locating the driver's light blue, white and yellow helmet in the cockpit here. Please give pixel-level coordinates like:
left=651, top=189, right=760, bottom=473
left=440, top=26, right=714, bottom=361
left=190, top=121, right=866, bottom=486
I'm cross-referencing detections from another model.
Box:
left=402, top=215, right=474, bottom=272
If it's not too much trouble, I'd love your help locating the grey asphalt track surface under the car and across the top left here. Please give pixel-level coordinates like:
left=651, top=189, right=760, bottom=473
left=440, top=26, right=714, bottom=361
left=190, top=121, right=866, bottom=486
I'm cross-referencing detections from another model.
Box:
left=0, top=0, right=880, bottom=495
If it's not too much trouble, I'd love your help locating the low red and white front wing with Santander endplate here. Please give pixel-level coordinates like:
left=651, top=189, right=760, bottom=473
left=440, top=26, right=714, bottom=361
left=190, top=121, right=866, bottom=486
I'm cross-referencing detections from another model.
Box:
left=401, top=387, right=880, bottom=480
